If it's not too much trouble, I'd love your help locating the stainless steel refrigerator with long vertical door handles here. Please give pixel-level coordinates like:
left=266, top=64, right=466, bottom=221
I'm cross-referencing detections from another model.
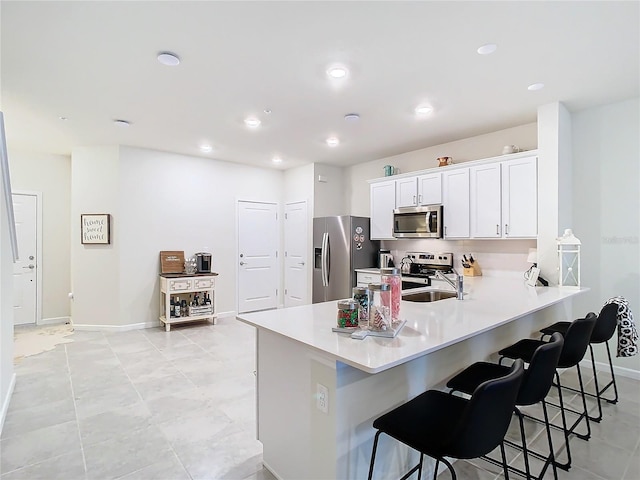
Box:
left=313, top=215, right=379, bottom=303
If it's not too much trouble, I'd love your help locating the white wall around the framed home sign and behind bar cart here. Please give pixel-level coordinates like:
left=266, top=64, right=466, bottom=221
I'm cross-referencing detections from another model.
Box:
left=72, top=147, right=284, bottom=327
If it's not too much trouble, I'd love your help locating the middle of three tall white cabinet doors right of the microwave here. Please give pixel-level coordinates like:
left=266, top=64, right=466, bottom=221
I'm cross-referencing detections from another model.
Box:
left=469, top=163, right=502, bottom=238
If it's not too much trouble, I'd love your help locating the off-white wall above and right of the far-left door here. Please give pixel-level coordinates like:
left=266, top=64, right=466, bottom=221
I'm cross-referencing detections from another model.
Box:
left=9, top=151, right=71, bottom=321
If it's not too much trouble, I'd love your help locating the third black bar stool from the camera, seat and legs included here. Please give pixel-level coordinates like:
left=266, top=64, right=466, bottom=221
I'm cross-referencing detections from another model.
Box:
left=498, top=313, right=598, bottom=470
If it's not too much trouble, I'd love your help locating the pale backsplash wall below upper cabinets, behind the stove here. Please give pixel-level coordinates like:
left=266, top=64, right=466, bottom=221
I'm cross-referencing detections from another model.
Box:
left=381, top=239, right=536, bottom=276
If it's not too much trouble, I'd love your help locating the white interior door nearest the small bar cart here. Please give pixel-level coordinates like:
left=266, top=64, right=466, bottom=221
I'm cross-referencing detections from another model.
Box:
left=238, top=202, right=279, bottom=313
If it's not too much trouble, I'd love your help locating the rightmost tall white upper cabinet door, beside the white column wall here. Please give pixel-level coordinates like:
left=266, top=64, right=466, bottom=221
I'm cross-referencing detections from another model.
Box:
left=502, top=157, right=538, bottom=238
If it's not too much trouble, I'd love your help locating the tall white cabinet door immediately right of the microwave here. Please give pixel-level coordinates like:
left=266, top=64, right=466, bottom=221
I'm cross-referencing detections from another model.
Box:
left=442, top=168, right=469, bottom=238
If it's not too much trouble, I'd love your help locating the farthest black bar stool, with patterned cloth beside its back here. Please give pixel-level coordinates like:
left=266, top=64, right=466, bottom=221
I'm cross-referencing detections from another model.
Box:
left=540, top=303, right=618, bottom=422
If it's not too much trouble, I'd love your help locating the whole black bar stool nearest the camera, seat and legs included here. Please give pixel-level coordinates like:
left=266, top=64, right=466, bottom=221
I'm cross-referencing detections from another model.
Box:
left=369, top=361, right=524, bottom=480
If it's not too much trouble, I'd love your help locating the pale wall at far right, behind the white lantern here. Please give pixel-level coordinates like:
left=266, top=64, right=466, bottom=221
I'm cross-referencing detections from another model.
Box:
left=572, top=98, right=640, bottom=371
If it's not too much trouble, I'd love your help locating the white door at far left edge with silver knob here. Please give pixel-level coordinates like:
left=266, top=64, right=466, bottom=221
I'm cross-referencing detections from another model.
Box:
left=13, top=194, right=39, bottom=325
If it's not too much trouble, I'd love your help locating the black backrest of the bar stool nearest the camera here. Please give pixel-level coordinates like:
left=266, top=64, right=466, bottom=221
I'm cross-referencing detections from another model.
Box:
left=443, top=360, right=524, bottom=458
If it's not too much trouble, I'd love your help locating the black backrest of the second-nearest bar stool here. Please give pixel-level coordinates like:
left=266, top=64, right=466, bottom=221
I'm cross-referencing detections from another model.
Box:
left=516, top=332, right=564, bottom=405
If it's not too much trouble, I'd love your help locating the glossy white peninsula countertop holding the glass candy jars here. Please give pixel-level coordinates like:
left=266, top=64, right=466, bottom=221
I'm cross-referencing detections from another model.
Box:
left=237, top=277, right=588, bottom=373
